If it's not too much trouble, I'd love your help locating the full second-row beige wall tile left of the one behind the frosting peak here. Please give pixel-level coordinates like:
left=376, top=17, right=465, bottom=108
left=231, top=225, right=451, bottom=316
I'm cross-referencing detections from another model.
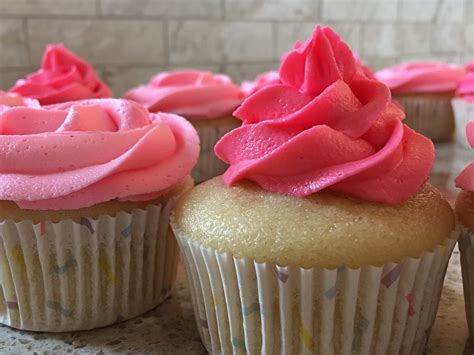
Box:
left=168, top=21, right=273, bottom=64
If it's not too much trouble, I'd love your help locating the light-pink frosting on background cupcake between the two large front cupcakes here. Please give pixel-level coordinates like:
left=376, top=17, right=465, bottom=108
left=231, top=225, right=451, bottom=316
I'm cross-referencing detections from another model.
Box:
left=125, top=70, right=245, bottom=119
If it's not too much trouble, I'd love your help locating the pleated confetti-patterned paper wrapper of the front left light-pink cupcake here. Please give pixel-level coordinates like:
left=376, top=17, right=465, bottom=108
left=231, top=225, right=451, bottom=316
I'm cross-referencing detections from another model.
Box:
left=0, top=201, right=179, bottom=332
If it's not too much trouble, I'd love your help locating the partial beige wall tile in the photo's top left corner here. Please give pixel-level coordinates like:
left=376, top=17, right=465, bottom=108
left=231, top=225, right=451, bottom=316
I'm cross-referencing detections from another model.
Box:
left=0, top=0, right=96, bottom=15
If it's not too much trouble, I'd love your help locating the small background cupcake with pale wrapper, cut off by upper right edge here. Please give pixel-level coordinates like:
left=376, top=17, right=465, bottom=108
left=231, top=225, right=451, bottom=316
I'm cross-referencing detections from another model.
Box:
left=451, top=67, right=474, bottom=148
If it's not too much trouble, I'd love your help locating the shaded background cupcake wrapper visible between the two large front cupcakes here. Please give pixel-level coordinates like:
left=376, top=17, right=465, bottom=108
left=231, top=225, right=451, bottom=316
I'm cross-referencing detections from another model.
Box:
left=191, top=121, right=240, bottom=183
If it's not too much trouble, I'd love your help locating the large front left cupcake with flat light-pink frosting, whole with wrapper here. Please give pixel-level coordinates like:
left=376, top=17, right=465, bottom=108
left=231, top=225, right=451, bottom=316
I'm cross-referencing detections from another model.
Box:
left=0, top=99, right=199, bottom=332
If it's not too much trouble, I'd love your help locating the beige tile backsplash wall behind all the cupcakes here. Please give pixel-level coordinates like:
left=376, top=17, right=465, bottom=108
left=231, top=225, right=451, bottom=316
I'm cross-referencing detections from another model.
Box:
left=0, top=0, right=474, bottom=95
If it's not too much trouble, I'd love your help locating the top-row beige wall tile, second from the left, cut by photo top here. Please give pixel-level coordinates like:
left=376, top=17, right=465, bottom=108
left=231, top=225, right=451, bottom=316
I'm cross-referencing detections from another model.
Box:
left=101, top=0, right=222, bottom=18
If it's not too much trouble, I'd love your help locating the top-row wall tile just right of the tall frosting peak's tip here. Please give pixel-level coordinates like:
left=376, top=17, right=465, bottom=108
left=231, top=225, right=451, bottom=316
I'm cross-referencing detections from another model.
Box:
left=322, top=0, right=398, bottom=22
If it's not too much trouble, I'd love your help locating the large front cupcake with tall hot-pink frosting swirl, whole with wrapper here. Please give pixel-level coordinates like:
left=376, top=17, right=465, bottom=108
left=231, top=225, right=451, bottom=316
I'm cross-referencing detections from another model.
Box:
left=171, top=26, right=456, bottom=354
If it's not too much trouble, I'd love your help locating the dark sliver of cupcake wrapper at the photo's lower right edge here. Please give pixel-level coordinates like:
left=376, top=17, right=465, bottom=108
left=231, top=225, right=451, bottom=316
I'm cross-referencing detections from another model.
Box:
left=458, top=227, right=474, bottom=344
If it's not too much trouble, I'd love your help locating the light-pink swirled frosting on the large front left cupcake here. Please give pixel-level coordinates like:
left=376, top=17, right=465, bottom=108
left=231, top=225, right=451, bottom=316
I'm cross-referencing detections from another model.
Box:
left=0, top=99, right=199, bottom=210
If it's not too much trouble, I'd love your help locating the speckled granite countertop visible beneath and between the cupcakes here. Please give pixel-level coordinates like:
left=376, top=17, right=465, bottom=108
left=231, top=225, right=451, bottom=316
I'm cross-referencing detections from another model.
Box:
left=0, top=144, right=474, bottom=355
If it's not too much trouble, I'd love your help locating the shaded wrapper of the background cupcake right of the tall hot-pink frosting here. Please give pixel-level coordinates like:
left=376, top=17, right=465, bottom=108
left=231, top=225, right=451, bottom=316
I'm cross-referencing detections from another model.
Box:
left=394, top=96, right=454, bottom=141
